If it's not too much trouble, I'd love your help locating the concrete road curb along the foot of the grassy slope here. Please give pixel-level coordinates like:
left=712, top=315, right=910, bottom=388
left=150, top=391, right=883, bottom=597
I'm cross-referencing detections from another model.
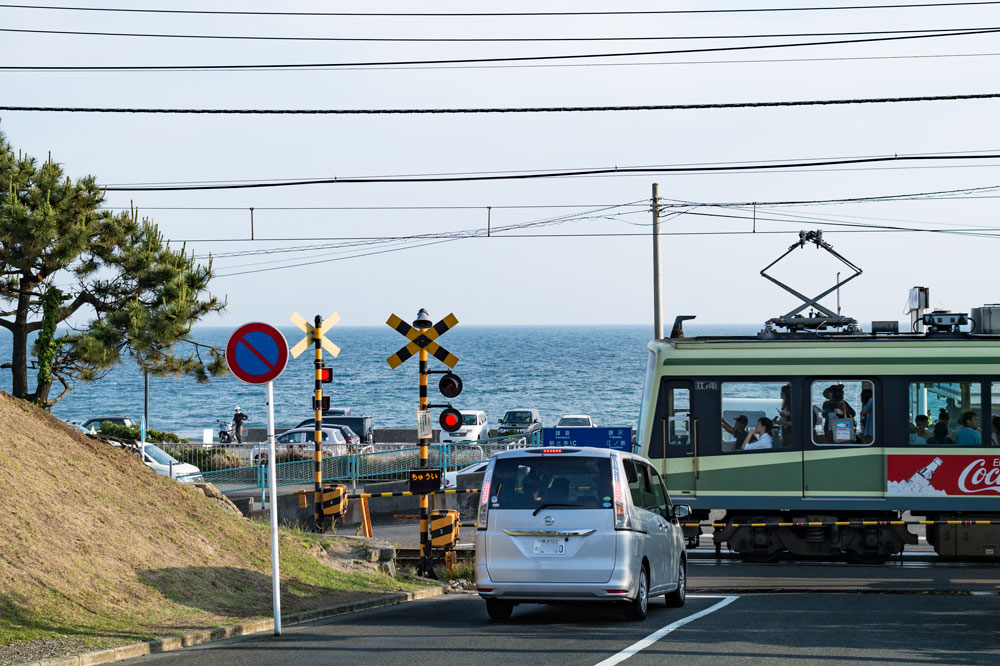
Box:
left=17, top=581, right=447, bottom=666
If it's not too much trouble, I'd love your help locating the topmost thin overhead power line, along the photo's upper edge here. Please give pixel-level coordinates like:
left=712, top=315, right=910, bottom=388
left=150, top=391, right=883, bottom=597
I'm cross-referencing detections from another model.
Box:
left=0, top=0, right=1000, bottom=18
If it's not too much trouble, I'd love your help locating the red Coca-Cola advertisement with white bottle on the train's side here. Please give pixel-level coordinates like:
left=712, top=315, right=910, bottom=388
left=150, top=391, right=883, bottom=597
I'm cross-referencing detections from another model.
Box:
left=886, top=453, right=1000, bottom=496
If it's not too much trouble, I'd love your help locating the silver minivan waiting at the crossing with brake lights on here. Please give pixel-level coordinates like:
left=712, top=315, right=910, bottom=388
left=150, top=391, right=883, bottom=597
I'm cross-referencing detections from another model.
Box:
left=476, top=447, right=690, bottom=620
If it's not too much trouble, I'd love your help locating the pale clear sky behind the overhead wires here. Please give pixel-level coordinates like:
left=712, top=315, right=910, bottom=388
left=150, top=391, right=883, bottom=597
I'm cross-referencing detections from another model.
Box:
left=0, top=0, right=1000, bottom=327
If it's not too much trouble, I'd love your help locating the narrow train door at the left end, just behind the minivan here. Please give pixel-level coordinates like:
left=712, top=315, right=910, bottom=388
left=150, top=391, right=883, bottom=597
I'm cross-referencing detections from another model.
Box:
left=646, top=378, right=698, bottom=497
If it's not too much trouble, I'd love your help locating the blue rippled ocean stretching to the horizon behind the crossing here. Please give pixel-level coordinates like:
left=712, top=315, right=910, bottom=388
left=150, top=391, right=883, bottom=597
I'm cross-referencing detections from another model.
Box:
left=0, top=323, right=760, bottom=440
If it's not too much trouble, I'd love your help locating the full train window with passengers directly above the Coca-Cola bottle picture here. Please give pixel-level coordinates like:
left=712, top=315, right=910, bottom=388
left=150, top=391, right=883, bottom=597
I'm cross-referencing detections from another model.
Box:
left=909, top=381, right=995, bottom=446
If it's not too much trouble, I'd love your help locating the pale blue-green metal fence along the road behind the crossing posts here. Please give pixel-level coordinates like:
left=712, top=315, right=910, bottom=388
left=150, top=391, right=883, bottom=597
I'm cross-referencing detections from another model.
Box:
left=178, top=432, right=541, bottom=493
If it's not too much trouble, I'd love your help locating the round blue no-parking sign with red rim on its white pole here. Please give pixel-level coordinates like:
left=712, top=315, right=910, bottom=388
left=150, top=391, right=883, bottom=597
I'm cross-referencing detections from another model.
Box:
left=226, top=322, right=288, bottom=636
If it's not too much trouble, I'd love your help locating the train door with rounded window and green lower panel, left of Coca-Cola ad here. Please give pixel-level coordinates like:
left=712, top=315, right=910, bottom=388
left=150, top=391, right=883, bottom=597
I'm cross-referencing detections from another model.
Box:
left=802, top=378, right=885, bottom=498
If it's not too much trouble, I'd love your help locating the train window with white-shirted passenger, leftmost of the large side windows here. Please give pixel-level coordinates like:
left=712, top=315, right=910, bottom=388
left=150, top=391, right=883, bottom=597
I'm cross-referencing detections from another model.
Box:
left=722, top=382, right=792, bottom=451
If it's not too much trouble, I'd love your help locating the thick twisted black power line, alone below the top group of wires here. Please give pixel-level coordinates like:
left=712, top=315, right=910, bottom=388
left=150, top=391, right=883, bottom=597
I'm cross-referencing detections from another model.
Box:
left=0, top=92, right=1000, bottom=116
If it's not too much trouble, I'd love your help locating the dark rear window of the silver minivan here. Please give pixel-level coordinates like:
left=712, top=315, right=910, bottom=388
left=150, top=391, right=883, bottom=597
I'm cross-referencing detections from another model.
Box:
left=490, top=456, right=612, bottom=509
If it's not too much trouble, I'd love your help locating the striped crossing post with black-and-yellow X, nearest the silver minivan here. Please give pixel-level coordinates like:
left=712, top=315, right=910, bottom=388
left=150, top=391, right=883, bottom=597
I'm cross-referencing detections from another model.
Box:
left=385, top=308, right=458, bottom=578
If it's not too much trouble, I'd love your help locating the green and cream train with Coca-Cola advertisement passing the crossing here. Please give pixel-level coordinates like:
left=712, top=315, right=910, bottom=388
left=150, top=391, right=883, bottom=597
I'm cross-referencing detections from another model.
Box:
left=637, top=304, right=1000, bottom=562
